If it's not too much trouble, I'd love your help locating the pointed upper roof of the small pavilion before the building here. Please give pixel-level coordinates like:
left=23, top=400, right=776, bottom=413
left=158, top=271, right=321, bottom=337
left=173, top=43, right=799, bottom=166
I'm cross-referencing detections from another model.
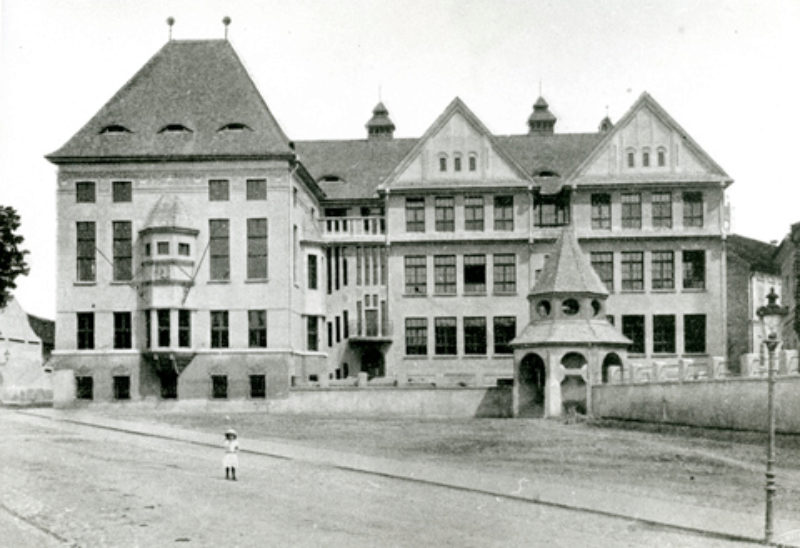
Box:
left=528, top=227, right=608, bottom=296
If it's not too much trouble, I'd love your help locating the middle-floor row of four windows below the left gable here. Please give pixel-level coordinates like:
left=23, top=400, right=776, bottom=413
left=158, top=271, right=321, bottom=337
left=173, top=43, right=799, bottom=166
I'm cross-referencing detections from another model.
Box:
left=404, top=253, right=517, bottom=295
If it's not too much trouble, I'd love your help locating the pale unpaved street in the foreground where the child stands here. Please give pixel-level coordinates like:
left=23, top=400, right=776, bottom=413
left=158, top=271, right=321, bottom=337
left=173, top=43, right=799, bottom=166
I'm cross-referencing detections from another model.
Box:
left=0, top=409, right=756, bottom=547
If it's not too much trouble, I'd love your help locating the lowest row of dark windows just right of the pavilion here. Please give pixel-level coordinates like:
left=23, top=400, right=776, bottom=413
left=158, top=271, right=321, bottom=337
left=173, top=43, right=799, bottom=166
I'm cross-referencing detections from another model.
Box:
left=609, top=314, right=706, bottom=354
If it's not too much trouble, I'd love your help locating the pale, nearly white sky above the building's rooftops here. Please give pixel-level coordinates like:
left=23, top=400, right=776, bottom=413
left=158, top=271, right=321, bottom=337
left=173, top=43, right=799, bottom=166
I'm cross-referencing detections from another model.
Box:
left=0, top=0, right=800, bottom=318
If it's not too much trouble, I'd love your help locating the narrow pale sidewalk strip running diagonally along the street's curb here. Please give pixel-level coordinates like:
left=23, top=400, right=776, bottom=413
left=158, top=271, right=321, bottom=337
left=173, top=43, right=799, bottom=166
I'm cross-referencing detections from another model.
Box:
left=20, top=409, right=800, bottom=546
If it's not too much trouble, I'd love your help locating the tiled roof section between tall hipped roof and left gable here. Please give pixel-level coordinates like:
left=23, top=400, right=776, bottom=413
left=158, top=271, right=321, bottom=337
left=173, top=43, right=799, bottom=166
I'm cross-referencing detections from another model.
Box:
left=295, top=139, right=417, bottom=200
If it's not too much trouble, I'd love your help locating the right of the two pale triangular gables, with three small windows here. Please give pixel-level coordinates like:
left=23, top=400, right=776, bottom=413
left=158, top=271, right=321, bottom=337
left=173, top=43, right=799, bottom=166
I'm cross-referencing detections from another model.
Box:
left=570, top=92, right=731, bottom=184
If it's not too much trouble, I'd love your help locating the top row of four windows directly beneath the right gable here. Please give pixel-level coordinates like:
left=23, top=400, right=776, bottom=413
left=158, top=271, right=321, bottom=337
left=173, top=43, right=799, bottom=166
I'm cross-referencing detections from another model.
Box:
left=591, top=191, right=703, bottom=230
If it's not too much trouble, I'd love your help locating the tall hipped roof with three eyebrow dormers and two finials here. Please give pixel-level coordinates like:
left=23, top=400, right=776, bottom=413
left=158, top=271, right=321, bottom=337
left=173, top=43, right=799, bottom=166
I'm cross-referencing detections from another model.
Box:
left=47, top=40, right=292, bottom=164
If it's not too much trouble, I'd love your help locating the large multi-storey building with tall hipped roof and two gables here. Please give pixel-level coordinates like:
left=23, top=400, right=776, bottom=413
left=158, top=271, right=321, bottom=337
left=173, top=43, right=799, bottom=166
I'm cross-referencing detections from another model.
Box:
left=48, top=36, right=732, bottom=399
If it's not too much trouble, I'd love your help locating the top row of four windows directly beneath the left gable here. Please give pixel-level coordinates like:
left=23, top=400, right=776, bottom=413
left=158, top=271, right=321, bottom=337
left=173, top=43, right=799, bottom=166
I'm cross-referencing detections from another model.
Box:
left=406, top=196, right=514, bottom=232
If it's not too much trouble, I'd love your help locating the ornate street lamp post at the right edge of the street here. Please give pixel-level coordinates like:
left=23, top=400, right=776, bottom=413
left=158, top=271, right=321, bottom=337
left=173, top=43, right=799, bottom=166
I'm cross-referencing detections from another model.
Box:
left=756, top=287, right=788, bottom=543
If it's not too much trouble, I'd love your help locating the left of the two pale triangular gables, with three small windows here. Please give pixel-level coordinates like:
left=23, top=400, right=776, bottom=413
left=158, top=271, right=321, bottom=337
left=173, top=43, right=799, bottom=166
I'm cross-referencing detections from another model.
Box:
left=380, top=97, right=530, bottom=189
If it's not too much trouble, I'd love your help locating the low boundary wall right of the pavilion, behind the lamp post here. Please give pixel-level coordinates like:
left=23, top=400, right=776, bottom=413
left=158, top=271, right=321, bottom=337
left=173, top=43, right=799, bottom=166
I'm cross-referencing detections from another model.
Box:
left=592, top=375, right=800, bottom=433
